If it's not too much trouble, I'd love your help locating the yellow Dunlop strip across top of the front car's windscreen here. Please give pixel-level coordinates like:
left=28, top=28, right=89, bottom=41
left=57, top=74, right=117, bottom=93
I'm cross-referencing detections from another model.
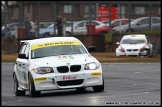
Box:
left=32, top=41, right=81, bottom=50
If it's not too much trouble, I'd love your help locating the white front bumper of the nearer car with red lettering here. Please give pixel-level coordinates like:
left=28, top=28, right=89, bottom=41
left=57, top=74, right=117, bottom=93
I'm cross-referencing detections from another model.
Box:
left=33, top=70, right=103, bottom=91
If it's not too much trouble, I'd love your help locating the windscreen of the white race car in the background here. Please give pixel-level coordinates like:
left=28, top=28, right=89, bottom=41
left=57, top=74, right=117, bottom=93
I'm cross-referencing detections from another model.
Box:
left=121, top=39, right=146, bottom=44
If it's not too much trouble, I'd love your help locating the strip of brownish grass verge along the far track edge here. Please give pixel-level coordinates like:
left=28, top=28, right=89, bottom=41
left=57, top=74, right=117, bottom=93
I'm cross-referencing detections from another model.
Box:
left=1, top=52, right=160, bottom=63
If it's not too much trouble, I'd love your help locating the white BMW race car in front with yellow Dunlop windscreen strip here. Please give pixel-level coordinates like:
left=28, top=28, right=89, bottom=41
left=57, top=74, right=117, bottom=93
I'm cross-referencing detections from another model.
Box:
left=13, top=37, right=104, bottom=97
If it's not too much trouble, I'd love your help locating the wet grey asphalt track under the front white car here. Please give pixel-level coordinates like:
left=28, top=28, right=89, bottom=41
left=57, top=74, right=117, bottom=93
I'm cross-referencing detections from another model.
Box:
left=1, top=63, right=161, bottom=106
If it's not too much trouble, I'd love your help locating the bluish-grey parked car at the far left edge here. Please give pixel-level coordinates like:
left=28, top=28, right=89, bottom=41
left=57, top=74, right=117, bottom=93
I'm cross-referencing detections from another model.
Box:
left=1, top=23, right=19, bottom=38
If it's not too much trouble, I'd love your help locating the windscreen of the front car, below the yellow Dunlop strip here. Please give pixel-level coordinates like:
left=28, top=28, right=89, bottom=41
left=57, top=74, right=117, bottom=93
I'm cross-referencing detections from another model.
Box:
left=31, top=45, right=87, bottom=59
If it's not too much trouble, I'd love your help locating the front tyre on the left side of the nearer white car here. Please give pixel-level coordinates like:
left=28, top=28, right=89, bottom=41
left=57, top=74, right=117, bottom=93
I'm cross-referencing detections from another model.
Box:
left=29, top=75, right=41, bottom=97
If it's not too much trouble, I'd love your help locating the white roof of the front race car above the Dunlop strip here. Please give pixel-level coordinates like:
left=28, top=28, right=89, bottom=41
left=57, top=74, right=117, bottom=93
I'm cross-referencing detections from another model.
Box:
left=25, top=37, right=79, bottom=45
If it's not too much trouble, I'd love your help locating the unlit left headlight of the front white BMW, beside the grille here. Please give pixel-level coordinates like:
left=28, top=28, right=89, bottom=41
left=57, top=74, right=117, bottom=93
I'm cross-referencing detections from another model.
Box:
left=34, top=67, right=54, bottom=74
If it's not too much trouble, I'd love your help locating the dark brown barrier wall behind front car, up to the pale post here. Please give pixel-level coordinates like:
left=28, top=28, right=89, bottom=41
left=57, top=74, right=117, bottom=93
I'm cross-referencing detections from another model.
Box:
left=1, top=35, right=105, bottom=54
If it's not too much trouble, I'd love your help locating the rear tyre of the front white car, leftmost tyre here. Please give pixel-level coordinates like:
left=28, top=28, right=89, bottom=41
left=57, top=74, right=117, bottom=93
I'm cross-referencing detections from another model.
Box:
left=14, top=74, right=25, bottom=96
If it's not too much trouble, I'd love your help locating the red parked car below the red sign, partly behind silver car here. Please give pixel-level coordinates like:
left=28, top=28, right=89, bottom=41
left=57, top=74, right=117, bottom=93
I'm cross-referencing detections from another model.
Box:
left=103, top=18, right=132, bottom=28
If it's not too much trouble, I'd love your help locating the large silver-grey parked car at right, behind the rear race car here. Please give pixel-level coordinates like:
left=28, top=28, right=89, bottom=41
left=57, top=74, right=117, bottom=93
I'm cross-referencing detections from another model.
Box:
left=112, top=17, right=161, bottom=33
